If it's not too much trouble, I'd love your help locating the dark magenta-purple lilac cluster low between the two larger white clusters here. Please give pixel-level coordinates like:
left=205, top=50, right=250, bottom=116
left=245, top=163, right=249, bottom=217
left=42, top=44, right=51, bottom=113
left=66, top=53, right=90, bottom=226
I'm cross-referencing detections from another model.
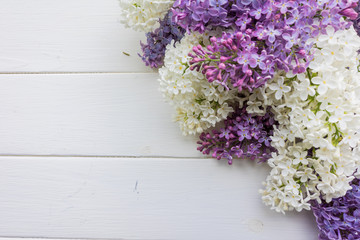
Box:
left=198, top=108, right=275, bottom=164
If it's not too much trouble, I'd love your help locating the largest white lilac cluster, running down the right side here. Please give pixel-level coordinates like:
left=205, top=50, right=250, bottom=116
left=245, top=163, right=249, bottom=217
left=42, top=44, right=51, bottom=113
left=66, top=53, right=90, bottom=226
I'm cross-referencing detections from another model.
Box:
left=256, top=27, right=360, bottom=212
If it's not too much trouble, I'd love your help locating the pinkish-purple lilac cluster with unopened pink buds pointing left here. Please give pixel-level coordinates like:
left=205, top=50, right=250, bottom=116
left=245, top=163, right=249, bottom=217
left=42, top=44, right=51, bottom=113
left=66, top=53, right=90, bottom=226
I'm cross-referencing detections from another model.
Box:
left=189, top=30, right=276, bottom=91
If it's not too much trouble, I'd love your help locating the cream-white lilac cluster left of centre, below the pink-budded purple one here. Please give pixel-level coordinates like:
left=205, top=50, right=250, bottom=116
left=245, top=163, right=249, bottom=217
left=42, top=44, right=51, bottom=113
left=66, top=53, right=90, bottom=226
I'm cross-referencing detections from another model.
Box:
left=159, top=34, right=238, bottom=135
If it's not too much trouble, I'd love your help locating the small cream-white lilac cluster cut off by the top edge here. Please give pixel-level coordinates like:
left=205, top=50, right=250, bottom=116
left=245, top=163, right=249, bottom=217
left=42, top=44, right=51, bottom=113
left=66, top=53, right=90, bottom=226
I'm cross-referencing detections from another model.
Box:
left=120, top=0, right=174, bottom=32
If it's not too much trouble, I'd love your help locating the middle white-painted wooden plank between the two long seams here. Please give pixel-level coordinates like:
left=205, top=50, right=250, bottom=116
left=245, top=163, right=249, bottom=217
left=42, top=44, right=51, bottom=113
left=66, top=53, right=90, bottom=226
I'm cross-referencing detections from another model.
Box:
left=0, top=74, right=202, bottom=157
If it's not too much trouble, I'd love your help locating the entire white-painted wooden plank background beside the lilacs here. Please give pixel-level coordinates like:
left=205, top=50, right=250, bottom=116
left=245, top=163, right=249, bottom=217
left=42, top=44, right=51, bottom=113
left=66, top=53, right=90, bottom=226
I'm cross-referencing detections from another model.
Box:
left=0, top=0, right=317, bottom=240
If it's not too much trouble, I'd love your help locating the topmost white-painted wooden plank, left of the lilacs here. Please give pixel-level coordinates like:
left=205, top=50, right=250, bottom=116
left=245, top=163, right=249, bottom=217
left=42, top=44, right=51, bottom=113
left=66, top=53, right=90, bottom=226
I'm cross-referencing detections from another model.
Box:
left=0, top=0, right=151, bottom=73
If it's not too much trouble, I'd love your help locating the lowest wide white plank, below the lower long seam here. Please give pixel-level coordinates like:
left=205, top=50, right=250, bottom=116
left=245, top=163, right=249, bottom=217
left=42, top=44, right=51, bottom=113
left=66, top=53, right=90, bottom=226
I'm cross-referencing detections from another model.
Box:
left=0, top=157, right=317, bottom=240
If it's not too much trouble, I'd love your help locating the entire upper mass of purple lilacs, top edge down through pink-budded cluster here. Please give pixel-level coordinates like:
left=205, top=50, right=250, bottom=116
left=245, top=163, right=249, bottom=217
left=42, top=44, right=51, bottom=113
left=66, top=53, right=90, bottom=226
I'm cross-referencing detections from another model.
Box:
left=183, top=0, right=357, bottom=91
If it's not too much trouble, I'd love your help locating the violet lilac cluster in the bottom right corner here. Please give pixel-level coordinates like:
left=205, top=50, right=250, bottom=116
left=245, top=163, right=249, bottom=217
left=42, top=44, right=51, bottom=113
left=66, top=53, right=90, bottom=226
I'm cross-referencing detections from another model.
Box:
left=312, top=179, right=360, bottom=240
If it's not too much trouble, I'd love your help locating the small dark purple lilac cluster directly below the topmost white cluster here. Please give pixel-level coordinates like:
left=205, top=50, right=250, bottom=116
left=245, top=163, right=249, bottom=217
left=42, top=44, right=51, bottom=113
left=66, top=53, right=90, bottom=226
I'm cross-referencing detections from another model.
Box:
left=139, top=12, right=185, bottom=68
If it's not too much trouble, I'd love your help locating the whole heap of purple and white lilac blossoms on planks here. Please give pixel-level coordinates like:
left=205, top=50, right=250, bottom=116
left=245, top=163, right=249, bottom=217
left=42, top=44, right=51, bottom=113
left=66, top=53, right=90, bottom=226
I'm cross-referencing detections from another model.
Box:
left=121, top=0, right=360, bottom=240
